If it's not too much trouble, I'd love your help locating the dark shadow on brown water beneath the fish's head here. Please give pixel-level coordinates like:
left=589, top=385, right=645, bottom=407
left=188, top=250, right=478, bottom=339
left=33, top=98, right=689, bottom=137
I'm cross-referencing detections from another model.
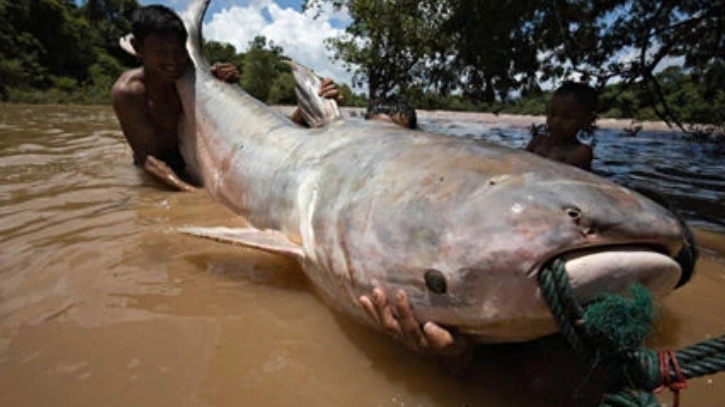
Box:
left=337, top=310, right=603, bottom=407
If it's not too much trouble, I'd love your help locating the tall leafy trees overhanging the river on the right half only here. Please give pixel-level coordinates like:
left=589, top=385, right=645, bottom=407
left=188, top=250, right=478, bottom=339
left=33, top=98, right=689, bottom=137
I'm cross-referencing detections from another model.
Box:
left=306, top=0, right=725, bottom=134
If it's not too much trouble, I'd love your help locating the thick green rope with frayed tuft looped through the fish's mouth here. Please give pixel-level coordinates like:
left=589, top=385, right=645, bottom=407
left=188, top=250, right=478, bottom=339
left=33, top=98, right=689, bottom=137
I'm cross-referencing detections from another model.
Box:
left=538, top=259, right=725, bottom=407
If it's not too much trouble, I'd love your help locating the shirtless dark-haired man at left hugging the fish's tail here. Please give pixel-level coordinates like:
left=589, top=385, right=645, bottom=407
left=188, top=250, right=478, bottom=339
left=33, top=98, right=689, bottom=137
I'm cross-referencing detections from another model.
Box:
left=111, top=5, right=239, bottom=191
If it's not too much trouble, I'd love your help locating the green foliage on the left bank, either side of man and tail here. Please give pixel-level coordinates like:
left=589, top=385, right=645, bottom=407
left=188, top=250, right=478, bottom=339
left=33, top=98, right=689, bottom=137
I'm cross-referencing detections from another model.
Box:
left=0, top=0, right=355, bottom=104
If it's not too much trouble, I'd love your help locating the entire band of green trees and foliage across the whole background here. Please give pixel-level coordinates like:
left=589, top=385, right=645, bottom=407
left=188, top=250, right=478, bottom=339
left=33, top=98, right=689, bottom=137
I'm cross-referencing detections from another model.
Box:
left=0, top=0, right=725, bottom=137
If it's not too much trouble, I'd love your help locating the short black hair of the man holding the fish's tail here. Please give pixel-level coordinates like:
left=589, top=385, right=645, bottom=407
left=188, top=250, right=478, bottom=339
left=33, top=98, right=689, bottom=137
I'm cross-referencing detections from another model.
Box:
left=131, top=4, right=187, bottom=45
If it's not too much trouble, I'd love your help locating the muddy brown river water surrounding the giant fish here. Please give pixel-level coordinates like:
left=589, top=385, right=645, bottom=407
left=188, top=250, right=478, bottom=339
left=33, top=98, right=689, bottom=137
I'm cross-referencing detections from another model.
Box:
left=0, top=105, right=725, bottom=407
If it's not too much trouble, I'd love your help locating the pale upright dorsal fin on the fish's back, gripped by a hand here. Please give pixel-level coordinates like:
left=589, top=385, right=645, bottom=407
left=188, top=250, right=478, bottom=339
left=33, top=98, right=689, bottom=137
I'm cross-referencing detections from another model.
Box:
left=285, top=60, right=342, bottom=127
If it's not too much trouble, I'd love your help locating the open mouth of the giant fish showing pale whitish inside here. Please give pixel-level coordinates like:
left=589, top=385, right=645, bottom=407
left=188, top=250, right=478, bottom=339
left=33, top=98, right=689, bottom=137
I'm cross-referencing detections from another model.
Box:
left=547, top=246, right=683, bottom=304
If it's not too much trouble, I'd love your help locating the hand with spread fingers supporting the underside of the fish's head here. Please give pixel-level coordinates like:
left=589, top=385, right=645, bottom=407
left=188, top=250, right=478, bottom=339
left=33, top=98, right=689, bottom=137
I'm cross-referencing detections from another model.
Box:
left=359, top=288, right=473, bottom=359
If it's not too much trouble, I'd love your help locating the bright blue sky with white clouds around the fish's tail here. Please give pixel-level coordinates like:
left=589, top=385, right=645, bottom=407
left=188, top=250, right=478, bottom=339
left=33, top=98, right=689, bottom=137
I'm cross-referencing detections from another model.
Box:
left=139, top=0, right=359, bottom=87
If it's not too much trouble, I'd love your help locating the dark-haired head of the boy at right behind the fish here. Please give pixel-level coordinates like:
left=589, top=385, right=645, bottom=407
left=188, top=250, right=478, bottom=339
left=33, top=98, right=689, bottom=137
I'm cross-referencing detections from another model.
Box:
left=546, top=82, right=599, bottom=140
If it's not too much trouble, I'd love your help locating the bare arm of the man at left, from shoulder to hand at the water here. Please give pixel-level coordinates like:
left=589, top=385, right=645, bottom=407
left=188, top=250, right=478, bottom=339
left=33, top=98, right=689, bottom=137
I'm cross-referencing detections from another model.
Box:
left=111, top=76, right=197, bottom=191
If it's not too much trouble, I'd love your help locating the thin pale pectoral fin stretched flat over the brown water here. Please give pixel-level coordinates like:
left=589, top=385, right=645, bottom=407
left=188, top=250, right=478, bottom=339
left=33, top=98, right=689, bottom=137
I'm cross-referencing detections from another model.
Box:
left=182, top=226, right=305, bottom=259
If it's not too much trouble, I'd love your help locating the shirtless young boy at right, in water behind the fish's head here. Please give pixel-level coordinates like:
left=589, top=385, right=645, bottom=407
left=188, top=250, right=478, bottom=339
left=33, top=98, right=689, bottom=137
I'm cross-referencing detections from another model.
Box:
left=526, top=82, right=598, bottom=170
